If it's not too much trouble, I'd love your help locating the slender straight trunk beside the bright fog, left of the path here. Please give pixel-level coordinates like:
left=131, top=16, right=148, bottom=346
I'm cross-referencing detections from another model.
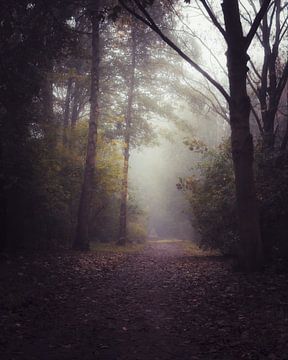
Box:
left=118, top=24, right=136, bottom=245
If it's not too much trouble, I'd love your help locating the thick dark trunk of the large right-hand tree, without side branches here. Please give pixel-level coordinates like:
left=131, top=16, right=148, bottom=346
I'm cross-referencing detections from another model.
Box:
left=222, top=0, right=263, bottom=271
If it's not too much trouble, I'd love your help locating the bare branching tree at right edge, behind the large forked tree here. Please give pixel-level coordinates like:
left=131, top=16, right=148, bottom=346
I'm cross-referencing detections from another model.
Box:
left=240, top=0, right=288, bottom=151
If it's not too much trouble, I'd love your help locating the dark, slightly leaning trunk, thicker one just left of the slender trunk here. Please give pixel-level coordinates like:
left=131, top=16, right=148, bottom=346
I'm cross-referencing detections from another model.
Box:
left=73, top=9, right=100, bottom=250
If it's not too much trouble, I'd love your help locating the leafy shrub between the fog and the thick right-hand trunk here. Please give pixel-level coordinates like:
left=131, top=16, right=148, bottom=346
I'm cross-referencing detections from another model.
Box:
left=187, top=144, right=238, bottom=254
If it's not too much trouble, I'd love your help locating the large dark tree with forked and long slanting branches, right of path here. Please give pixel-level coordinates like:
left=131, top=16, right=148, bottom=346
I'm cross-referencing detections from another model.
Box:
left=119, top=0, right=271, bottom=271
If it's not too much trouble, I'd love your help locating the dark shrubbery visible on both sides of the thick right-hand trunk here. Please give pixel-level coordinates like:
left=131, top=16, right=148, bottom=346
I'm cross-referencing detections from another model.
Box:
left=181, top=143, right=288, bottom=257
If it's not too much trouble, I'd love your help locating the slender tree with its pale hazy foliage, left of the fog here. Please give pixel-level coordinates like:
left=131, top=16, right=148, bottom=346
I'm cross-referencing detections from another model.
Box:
left=100, top=16, right=174, bottom=245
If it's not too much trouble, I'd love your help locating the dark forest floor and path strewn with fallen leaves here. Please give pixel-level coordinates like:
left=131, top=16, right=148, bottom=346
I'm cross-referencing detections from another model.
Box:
left=0, top=242, right=288, bottom=360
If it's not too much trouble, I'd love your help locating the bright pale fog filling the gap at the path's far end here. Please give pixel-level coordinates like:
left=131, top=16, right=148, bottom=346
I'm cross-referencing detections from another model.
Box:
left=130, top=139, right=193, bottom=239
